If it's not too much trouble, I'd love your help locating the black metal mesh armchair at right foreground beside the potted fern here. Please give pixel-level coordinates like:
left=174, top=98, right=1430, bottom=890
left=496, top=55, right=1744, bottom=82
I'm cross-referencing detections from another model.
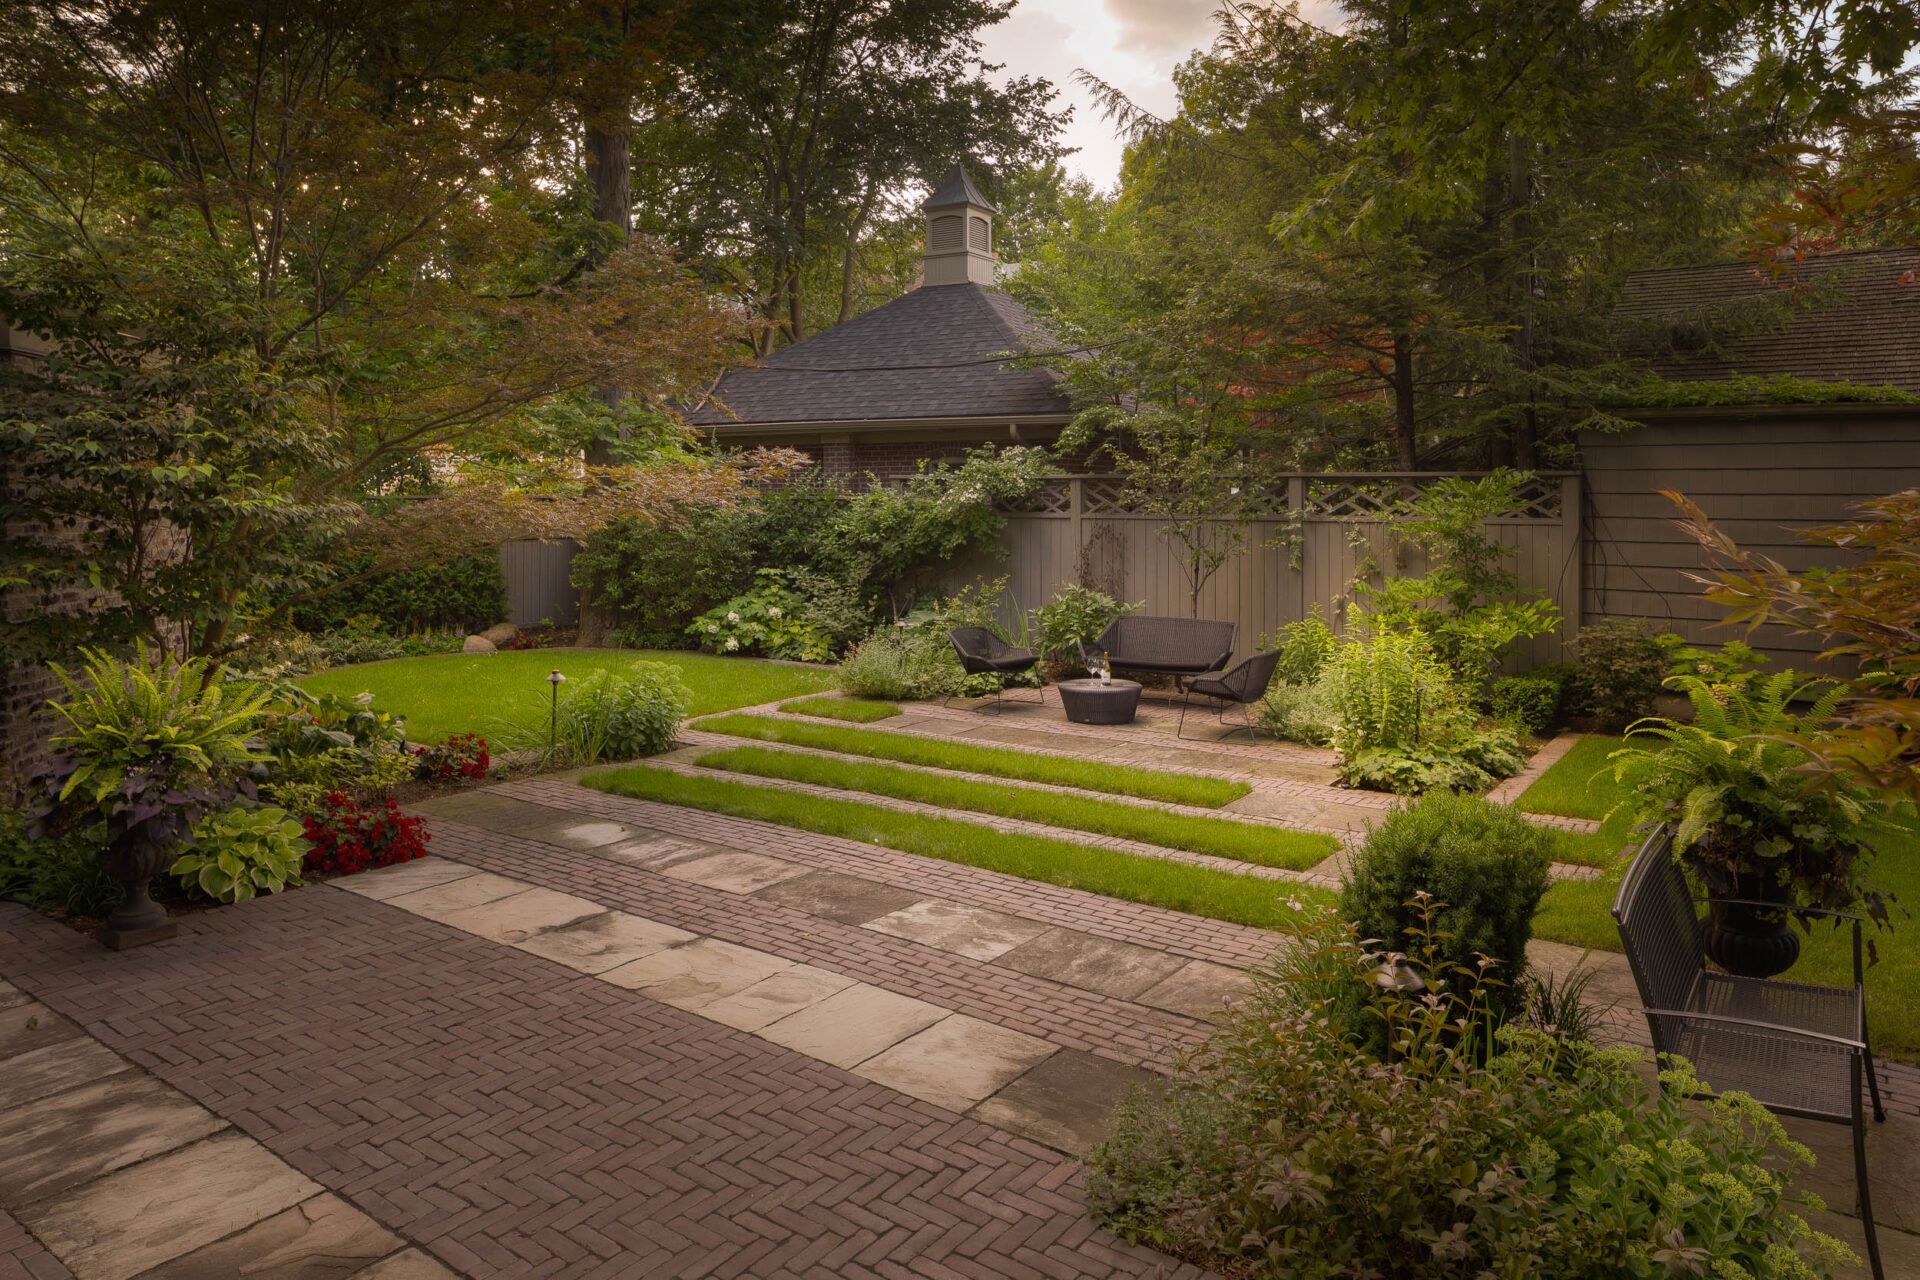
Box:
left=1613, top=827, right=1887, bottom=1280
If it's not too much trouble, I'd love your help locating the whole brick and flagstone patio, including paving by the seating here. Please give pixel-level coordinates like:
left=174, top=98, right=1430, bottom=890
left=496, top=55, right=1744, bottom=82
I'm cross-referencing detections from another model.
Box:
left=0, top=694, right=1920, bottom=1280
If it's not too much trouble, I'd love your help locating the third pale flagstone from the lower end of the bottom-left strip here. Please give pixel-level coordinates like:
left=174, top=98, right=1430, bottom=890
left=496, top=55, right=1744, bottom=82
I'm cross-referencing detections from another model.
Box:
left=15, top=1132, right=323, bottom=1280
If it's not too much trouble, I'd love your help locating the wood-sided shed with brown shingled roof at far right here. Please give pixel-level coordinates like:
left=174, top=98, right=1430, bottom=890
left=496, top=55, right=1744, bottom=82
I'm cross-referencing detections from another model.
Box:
left=1580, top=249, right=1920, bottom=668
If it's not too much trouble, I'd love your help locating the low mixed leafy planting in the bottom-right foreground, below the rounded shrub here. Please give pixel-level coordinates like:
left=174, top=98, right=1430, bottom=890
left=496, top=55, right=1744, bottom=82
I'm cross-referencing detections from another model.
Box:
left=1087, top=900, right=1857, bottom=1280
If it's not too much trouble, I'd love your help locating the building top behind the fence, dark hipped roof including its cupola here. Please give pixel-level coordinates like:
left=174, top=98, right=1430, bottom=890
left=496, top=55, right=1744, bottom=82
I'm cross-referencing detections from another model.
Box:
left=687, top=163, right=1073, bottom=476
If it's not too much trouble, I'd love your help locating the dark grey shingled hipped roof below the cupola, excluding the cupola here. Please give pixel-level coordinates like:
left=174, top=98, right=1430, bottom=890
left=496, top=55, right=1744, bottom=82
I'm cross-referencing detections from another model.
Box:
left=687, top=284, right=1073, bottom=428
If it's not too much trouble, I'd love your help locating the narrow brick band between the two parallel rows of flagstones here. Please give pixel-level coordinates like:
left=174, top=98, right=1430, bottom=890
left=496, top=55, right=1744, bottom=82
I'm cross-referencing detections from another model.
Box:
left=432, top=819, right=1213, bottom=1069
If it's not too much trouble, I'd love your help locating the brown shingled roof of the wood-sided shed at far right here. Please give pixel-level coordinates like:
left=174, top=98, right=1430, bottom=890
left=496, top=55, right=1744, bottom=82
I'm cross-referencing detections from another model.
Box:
left=1615, top=248, right=1920, bottom=391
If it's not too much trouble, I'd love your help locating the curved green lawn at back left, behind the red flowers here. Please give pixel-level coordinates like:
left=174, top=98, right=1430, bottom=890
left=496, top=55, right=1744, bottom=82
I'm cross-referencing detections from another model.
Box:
left=300, top=649, right=833, bottom=743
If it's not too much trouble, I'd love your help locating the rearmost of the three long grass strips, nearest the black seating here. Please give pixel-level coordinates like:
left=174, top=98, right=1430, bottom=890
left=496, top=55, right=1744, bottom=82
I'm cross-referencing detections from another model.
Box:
left=693, top=716, right=1252, bottom=808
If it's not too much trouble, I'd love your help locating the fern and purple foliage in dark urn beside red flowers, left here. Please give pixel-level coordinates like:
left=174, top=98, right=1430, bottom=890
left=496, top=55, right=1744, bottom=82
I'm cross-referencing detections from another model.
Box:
left=27, top=645, right=269, bottom=950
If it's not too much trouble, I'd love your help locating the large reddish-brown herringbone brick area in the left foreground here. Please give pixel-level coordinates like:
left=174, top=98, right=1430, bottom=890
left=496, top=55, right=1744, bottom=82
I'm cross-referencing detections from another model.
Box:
left=0, top=901, right=1200, bottom=1278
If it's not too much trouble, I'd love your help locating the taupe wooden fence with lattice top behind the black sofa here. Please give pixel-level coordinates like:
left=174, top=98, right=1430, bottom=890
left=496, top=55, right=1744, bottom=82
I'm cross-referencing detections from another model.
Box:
left=962, top=472, right=1582, bottom=666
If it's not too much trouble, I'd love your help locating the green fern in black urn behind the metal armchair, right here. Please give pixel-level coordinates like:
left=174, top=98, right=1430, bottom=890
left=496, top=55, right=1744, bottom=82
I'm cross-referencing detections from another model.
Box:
left=1611, top=672, right=1885, bottom=977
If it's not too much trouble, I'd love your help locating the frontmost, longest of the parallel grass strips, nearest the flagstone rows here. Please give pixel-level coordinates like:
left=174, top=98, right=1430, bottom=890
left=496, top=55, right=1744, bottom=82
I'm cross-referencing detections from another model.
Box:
left=582, top=764, right=1332, bottom=929
